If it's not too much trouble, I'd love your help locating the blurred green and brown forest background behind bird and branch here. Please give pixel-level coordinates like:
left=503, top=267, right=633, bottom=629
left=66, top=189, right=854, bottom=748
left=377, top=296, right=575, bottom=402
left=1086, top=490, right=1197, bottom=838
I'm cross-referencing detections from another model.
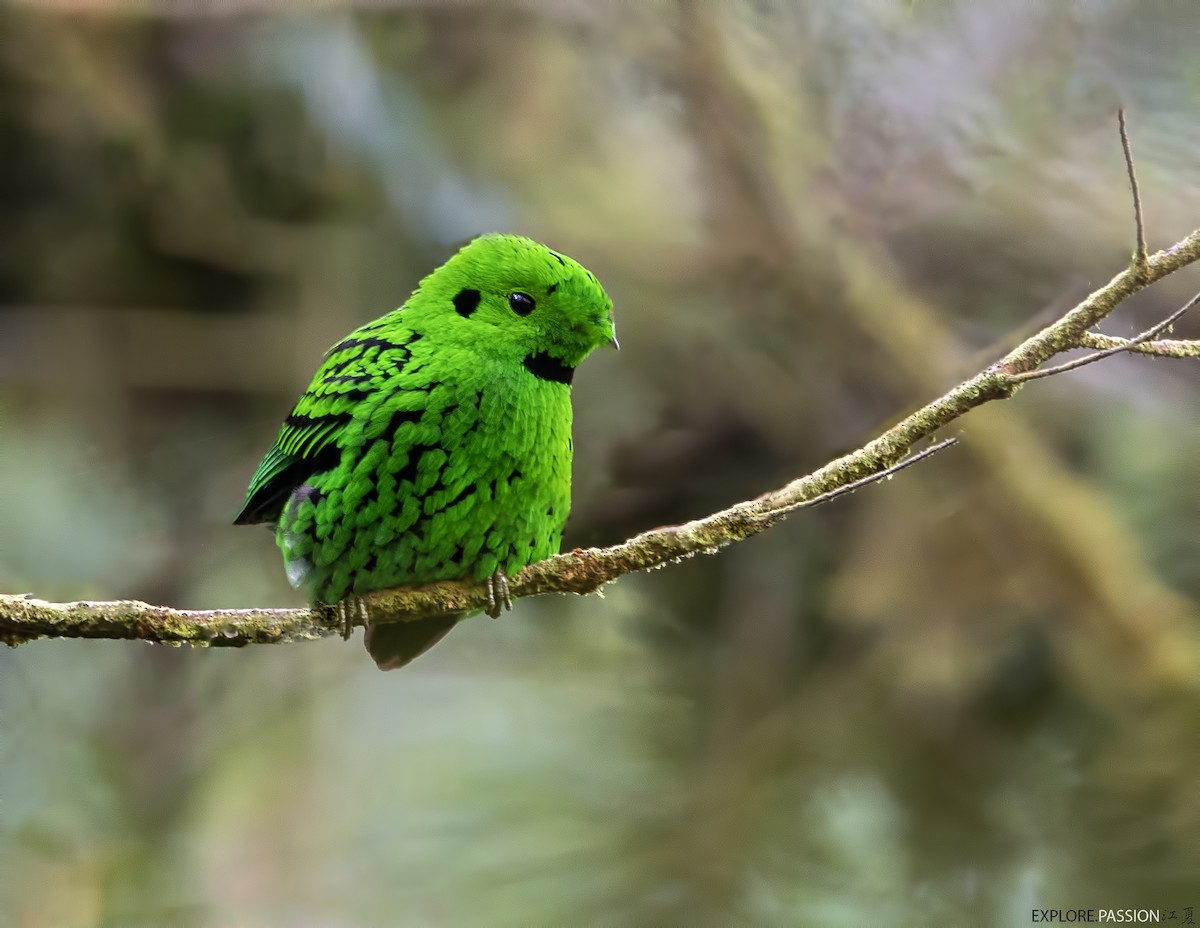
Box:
left=0, top=0, right=1200, bottom=928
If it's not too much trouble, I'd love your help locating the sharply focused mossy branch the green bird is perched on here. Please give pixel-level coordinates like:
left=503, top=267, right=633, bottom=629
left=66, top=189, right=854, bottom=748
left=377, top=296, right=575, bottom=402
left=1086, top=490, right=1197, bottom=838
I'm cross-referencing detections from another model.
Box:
left=0, top=119, right=1200, bottom=647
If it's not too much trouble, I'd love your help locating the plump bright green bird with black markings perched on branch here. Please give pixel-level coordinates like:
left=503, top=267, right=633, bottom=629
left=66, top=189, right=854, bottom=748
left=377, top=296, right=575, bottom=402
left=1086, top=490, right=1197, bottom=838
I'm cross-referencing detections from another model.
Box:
left=234, top=234, right=617, bottom=670
